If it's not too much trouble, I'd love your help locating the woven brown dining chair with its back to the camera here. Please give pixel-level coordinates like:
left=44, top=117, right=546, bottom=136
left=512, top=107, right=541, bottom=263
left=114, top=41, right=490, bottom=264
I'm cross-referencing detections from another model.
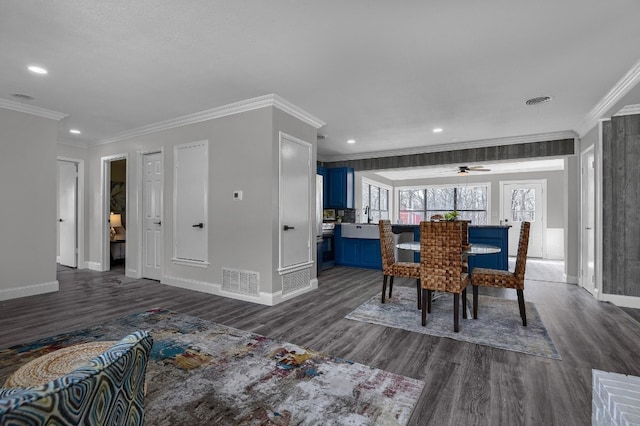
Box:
left=420, top=221, right=469, bottom=333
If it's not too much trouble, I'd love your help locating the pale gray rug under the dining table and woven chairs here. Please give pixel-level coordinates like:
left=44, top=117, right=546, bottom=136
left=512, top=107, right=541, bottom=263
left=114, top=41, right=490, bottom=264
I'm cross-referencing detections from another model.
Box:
left=345, top=287, right=561, bottom=359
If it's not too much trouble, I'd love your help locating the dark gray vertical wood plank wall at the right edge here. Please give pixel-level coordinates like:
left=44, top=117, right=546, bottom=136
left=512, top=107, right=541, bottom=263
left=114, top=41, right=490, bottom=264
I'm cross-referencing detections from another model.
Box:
left=602, top=115, right=640, bottom=296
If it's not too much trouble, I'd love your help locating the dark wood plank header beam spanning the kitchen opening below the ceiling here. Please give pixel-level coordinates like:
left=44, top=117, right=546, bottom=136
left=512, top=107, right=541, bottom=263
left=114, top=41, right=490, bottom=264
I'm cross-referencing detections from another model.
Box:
left=321, top=139, right=575, bottom=171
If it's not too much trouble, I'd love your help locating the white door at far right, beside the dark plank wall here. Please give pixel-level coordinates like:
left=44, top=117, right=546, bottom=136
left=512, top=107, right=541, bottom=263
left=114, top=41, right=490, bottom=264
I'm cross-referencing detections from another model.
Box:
left=581, top=148, right=595, bottom=293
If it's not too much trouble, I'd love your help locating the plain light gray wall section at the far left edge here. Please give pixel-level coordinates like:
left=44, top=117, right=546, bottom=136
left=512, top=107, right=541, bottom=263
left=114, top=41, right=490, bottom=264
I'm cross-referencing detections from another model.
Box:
left=0, top=108, right=58, bottom=300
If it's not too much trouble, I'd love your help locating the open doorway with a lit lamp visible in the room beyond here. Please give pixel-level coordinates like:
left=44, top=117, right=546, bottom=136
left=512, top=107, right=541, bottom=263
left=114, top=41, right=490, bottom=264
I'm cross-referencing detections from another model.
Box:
left=101, top=154, right=128, bottom=274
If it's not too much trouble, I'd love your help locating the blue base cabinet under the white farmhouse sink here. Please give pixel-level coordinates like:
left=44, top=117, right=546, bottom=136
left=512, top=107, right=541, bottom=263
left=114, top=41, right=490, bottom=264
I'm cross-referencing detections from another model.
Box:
left=334, top=225, right=382, bottom=270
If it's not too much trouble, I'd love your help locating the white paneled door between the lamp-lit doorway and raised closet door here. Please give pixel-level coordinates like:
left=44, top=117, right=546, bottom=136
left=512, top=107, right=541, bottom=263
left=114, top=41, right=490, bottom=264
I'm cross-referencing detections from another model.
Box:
left=142, top=152, right=163, bottom=280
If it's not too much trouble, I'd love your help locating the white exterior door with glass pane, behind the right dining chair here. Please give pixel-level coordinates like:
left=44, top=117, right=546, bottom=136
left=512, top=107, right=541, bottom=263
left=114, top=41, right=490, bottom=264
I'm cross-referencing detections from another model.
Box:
left=500, top=182, right=547, bottom=257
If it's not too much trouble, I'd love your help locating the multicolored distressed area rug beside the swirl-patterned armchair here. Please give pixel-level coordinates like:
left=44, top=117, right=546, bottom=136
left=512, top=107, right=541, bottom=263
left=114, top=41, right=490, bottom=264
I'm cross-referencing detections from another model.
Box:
left=0, top=309, right=424, bottom=425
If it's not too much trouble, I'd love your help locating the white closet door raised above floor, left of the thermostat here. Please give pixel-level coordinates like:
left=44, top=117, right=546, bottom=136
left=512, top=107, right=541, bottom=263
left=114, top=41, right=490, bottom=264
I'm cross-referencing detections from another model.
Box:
left=173, top=141, right=209, bottom=263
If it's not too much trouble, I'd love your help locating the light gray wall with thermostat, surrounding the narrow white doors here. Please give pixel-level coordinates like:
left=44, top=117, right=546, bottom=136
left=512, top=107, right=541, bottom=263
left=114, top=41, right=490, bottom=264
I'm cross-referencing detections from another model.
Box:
left=86, top=107, right=316, bottom=299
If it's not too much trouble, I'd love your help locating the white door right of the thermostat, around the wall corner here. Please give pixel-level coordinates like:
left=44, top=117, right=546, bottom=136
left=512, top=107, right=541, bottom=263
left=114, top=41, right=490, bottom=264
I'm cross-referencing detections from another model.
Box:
left=280, top=134, right=312, bottom=268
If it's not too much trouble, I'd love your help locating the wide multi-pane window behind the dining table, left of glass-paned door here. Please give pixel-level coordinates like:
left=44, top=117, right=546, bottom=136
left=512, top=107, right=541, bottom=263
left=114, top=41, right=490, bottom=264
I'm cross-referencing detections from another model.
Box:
left=398, top=185, right=489, bottom=225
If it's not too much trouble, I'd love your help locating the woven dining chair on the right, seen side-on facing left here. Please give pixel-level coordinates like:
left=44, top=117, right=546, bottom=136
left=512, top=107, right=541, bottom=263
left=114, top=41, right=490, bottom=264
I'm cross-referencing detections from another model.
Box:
left=471, top=221, right=531, bottom=327
